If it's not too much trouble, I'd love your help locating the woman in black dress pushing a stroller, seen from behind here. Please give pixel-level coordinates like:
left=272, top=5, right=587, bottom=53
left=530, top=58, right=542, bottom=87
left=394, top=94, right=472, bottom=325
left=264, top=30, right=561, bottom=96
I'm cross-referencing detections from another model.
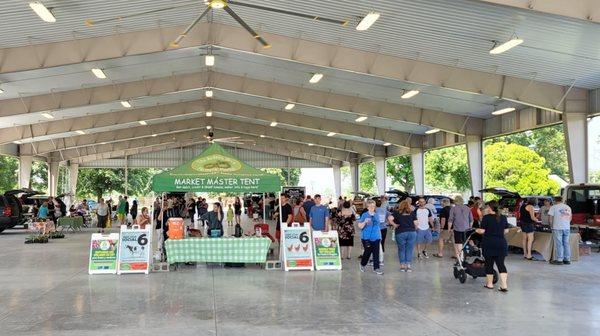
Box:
left=476, top=201, right=508, bottom=292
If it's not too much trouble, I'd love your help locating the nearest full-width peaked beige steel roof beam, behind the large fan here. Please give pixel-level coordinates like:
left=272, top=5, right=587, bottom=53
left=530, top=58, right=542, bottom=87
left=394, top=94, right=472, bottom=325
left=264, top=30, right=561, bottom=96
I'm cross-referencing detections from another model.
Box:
left=0, top=22, right=584, bottom=112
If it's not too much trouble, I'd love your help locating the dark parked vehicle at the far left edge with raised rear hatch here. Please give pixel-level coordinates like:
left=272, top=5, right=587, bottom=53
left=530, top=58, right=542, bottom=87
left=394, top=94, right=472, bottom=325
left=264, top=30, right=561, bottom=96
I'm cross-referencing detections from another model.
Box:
left=0, top=189, right=40, bottom=232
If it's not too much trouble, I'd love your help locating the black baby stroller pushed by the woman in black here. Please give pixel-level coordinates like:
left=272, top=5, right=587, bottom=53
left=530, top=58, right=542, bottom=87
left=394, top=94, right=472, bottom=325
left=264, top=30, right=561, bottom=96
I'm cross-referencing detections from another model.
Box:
left=454, top=230, right=498, bottom=284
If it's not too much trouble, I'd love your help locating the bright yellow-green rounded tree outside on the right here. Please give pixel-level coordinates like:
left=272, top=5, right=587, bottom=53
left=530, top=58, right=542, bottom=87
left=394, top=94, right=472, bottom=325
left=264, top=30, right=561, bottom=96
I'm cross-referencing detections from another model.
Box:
left=484, top=142, right=559, bottom=195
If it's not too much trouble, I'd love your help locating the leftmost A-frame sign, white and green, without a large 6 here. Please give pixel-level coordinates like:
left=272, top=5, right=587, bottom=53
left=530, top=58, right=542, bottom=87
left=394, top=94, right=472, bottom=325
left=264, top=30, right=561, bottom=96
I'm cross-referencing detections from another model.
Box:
left=88, top=233, right=119, bottom=274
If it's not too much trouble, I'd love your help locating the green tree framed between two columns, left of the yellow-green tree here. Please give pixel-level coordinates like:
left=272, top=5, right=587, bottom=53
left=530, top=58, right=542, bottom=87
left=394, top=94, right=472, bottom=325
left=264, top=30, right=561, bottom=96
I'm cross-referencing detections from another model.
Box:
left=425, top=145, right=471, bottom=194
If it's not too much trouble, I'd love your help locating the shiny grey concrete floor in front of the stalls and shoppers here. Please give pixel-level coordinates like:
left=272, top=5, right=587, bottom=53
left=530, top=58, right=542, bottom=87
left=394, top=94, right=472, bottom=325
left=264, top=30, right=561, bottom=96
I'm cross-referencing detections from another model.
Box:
left=0, top=220, right=600, bottom=336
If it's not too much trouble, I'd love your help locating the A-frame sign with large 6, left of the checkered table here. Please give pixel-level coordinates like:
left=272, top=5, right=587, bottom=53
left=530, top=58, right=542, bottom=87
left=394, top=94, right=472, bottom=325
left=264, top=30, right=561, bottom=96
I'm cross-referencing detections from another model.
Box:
left=117, top=227, right=152, bottom=274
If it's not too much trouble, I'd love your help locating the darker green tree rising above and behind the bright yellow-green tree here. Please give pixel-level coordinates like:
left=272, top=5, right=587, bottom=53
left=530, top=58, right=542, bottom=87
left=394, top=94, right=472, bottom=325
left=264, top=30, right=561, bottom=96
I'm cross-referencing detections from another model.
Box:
left=488, top=124, right=569, bottom=181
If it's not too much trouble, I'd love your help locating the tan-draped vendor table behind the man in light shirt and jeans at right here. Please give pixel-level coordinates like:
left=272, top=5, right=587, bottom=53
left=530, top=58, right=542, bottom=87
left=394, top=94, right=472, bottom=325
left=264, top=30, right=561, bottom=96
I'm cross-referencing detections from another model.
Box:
left=505, top=228, right=581, bottom=261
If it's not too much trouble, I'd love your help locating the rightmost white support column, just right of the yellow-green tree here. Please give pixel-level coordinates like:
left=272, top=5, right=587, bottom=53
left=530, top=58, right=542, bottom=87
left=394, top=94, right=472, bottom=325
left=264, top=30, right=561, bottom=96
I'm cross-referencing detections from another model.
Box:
left=563, top=112, right=588, bottom=183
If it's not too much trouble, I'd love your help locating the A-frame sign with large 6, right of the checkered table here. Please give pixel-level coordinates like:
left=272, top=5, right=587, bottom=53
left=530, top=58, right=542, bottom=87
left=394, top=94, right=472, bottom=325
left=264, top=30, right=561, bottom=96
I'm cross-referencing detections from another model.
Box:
left=281, top=226, right=314, bottom=271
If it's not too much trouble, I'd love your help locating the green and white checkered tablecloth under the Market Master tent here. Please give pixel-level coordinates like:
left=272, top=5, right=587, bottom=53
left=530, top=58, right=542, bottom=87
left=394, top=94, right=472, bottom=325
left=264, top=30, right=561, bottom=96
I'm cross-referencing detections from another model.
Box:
left=165, top=237, right=271, bottom=264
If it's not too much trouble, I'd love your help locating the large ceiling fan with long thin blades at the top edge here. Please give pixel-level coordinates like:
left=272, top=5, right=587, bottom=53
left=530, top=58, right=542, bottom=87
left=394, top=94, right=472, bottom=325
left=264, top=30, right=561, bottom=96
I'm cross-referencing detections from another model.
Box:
left=85, top=0, right=348, bottom=48
